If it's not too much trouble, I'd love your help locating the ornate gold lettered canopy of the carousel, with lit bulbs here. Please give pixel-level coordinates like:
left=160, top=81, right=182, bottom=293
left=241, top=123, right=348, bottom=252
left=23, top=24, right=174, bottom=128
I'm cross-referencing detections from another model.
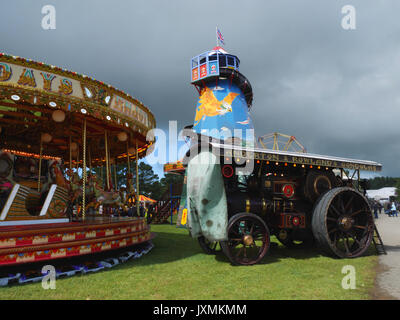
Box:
left=0, top=53, right=156, bottom=162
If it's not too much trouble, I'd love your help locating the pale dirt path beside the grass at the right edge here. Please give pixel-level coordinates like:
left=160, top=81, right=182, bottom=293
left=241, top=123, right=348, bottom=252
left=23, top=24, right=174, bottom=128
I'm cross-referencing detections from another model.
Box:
left=374, top=214, right=400, bottom=300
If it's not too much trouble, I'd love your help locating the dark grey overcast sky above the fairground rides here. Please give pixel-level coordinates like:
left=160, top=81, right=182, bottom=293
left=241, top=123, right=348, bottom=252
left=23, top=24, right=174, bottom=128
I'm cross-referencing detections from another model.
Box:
left=0, top=0, right=400, bottom=176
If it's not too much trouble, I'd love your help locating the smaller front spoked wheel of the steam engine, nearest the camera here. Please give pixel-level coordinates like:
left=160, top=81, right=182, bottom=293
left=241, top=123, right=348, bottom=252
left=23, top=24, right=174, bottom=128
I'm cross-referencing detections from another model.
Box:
left=220, top=213, right=270, bottom=265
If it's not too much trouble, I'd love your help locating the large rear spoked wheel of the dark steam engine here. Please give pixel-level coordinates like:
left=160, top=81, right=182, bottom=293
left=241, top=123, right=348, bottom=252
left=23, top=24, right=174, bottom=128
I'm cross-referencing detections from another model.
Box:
left=312, top=187, right=374, bottom=258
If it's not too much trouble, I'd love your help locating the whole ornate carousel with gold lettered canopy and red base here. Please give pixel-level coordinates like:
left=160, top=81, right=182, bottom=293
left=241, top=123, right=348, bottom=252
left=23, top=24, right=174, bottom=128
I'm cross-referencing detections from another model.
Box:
left=0, top=54, right=156, bottom=280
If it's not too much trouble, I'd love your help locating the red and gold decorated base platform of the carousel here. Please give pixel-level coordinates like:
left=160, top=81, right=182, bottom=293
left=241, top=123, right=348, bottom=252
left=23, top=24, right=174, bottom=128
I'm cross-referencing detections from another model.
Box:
left=0, top=217, right=154, bottom=266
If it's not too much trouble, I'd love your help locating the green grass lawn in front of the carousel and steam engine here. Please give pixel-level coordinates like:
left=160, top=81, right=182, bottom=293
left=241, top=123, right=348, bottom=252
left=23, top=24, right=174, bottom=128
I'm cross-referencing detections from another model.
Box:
left=0, top=225, right=377, bottom=300
